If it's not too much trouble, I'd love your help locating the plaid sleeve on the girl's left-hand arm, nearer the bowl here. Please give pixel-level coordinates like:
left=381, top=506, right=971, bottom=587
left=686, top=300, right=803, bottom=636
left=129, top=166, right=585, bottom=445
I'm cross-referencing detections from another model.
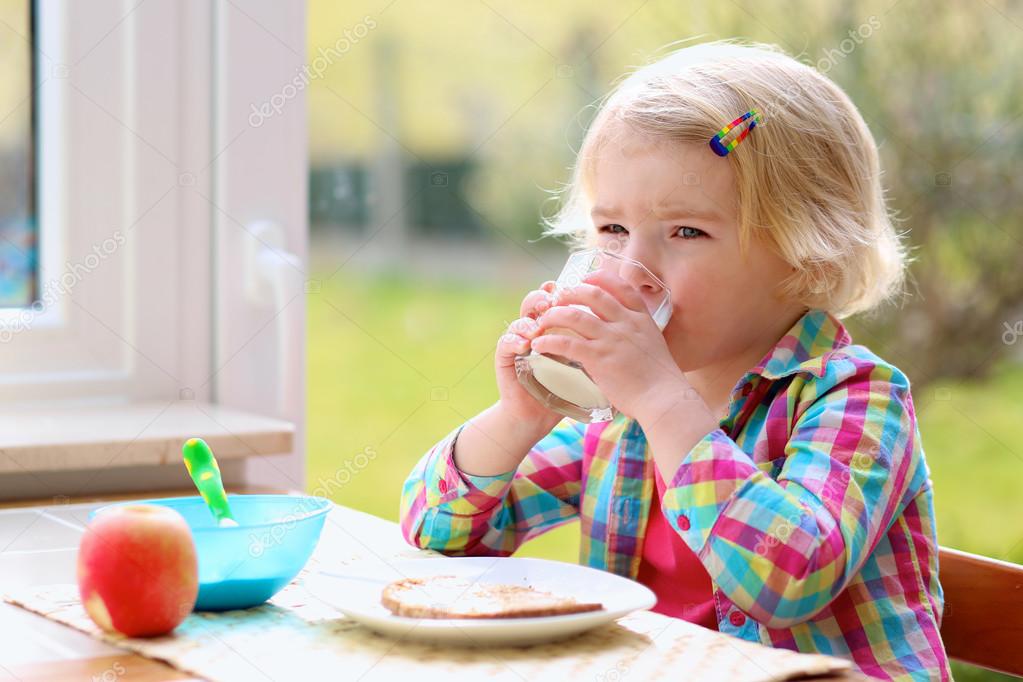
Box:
left=400, top=418, right=586, bottom=556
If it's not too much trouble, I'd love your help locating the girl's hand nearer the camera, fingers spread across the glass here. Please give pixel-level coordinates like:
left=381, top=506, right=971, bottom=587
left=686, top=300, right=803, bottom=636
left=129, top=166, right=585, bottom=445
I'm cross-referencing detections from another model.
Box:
left=532, top=270, right=694, bottom=426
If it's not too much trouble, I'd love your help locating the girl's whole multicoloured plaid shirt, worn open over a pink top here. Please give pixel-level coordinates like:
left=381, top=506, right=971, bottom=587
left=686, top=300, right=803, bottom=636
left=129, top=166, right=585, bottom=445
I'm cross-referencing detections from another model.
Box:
left=401, top=310, right=950, bottom=679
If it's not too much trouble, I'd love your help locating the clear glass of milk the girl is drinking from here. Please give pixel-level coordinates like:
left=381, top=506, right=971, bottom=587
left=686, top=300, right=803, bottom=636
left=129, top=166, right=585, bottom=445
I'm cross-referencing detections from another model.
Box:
left=515, top=248, right=671, bottom=423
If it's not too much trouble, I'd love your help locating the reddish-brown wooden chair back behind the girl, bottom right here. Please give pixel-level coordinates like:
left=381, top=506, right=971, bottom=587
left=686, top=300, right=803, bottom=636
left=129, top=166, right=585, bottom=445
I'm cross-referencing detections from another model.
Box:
left=938, top=547, right=1023, bottom=677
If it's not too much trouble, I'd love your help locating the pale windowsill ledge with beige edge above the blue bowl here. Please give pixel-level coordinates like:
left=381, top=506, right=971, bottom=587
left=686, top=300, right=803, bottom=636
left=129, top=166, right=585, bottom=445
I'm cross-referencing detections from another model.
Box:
left=0, top=401, right=295, bottom=473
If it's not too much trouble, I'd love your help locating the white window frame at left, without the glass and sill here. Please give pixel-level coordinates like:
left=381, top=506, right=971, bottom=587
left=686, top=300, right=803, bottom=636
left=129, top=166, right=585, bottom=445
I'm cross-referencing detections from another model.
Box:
left=0, top=0, right=308, bottom=495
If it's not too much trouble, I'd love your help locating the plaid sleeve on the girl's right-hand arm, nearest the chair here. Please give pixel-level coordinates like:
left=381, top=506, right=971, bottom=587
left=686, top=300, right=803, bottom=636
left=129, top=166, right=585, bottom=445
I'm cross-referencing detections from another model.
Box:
left=662, top=357, right=926, bottom=628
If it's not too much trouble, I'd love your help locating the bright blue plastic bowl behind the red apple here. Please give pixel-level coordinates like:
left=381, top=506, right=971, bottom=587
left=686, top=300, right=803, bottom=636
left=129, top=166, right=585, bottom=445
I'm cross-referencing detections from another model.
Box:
left=89, top=495, right=330, bottom=610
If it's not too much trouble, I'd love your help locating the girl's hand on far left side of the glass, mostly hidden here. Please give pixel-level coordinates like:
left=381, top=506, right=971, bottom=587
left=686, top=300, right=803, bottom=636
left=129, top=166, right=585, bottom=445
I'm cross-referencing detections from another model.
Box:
left=494, top=281, right=563, bottom=434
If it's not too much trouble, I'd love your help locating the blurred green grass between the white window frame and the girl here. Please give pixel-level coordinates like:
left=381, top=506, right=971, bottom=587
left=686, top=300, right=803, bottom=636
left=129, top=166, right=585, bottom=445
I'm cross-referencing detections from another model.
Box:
left=308, top=275, right=579, bottom=561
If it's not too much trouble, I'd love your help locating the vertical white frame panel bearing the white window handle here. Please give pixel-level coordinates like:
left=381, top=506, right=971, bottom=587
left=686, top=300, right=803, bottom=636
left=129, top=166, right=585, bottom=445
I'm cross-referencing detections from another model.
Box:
left=213, top=0, right=306, bottom=488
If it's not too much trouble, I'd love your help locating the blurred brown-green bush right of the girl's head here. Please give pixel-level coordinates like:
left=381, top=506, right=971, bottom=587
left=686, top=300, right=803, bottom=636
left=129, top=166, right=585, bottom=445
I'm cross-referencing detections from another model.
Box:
left=831, top=3, right=1023, bottom=384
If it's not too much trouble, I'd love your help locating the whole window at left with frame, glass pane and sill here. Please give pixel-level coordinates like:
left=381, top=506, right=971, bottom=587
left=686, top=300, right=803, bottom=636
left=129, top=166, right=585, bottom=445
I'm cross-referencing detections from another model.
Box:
left=0, top=0, right=307, bottom=498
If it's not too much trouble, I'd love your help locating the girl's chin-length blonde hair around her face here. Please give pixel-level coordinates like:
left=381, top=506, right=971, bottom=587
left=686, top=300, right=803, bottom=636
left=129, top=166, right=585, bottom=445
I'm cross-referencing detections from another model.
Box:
left=544, top=41, right=906, bottom=317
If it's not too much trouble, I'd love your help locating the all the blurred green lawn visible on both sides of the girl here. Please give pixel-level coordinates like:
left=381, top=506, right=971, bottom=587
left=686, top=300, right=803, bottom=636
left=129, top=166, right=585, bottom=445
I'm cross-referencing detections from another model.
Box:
left=308, top=274, right=1023, bottom=679
